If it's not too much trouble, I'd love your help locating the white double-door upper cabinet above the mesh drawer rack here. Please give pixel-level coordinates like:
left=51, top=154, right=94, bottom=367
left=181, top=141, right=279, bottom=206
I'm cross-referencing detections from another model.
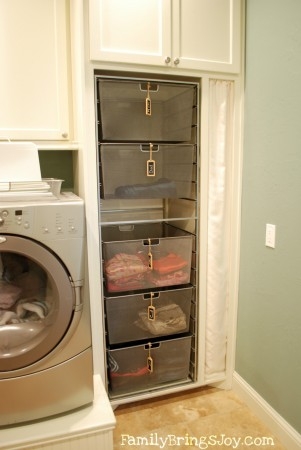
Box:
left=90, top=0, right=241, bottom=73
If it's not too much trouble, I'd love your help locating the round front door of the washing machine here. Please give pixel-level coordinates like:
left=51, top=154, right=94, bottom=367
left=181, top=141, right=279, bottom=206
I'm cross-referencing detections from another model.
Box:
left=0, top=235, right=75, bottom=372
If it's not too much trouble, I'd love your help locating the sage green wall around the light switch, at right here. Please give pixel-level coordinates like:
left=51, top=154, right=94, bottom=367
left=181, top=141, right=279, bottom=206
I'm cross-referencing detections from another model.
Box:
left=236, top=0, right=301, bottom=432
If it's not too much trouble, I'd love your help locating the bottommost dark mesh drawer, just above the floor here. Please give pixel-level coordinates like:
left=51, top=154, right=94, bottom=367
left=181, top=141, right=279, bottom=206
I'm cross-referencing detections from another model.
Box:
left=108, top=335, right=191, bottom=394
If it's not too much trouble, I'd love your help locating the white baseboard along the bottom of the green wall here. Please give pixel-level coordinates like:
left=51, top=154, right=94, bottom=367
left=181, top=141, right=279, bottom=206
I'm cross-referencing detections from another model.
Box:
left=232, top=372, right=301, bottom=450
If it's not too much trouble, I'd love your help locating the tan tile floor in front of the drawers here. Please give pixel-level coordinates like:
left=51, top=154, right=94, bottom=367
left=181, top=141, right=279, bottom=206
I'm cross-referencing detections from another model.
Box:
left=114, top=387, right=285, bottom=450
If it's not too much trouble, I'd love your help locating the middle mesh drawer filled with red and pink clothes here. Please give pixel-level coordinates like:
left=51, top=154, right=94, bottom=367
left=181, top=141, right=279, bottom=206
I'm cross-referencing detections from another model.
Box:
left=102, top=223, right=193, bottom=292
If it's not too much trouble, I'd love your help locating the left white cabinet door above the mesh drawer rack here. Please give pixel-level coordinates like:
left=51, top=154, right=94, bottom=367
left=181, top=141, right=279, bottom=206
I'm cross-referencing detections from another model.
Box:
left=90, top=0, right=171, bottom=66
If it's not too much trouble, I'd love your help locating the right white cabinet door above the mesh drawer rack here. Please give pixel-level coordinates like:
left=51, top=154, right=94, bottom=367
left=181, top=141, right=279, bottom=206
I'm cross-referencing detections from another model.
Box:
left=172, top=0, right=241, bottom=72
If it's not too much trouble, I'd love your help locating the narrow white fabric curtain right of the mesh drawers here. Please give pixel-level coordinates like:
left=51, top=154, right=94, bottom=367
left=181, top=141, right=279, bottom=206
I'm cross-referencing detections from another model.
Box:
left=205, top=80, right=234, bottom=379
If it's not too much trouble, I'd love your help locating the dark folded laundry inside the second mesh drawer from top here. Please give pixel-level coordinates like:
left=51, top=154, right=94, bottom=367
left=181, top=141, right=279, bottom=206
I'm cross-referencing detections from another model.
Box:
left=115, top=178, right=177, bottom=198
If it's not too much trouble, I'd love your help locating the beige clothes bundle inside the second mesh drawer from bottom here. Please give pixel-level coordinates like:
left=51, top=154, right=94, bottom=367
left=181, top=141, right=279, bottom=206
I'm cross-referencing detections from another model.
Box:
left=135, top=303, right=187, bottom=336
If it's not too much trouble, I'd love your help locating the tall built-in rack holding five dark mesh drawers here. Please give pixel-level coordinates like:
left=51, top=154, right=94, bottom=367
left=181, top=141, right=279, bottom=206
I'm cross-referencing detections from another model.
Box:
left=95, top=73, right=199, bottom=401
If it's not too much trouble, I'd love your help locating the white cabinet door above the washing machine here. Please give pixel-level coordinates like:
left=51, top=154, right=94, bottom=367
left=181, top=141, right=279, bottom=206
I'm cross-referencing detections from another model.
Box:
left=0, top=0, right=69, bottom=140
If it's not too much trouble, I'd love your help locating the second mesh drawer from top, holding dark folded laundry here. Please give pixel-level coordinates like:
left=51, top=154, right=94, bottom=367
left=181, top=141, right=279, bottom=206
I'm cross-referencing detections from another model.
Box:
left=99, top=144, right=195, bottom=199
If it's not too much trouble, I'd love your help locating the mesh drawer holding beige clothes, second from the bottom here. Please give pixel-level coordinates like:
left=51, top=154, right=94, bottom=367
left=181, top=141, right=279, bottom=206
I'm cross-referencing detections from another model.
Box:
left=105, top=287, right=193, bottom=344
